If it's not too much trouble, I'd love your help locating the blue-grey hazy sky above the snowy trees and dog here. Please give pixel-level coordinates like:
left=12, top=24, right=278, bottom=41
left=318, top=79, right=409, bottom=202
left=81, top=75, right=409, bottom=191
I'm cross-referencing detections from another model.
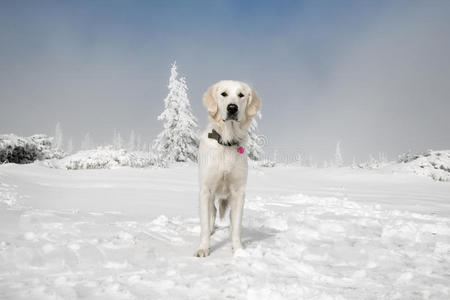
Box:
left=0, top=0, right=450, bottom=163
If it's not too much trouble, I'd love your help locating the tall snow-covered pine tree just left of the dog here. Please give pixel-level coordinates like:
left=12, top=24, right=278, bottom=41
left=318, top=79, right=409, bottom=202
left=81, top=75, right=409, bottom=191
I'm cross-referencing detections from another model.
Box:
left=153, top=62, right=199, bottom=162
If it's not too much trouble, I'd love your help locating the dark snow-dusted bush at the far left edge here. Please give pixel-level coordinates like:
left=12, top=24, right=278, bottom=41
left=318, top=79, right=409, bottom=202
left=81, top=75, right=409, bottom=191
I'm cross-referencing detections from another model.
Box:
left=0, top=134, right=65, bottom=164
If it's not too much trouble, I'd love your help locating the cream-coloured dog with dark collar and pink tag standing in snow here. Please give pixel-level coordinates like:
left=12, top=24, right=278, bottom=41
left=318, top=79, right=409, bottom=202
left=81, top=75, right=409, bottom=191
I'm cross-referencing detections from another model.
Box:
left=195, top=80, right=261, bottom=257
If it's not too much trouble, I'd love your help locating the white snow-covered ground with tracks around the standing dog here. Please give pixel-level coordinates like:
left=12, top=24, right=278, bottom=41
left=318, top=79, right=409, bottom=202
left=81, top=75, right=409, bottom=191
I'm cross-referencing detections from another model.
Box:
left=0, top=163, right=450, bottom=300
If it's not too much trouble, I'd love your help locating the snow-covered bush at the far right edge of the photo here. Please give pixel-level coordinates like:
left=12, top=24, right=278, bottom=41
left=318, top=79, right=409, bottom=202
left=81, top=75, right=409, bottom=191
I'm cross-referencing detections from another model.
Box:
left=398, top=150, right=450, bottom=181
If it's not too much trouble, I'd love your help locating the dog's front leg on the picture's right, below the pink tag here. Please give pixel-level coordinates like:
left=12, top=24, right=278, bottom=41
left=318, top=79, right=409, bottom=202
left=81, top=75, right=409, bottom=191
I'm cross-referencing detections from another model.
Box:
left=230, top=188, right=245, bottom=252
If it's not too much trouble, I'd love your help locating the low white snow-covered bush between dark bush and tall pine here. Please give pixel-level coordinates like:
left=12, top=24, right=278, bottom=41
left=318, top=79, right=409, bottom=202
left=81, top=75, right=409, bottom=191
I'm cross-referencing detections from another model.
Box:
left=59, top=147, right=161, bottom=170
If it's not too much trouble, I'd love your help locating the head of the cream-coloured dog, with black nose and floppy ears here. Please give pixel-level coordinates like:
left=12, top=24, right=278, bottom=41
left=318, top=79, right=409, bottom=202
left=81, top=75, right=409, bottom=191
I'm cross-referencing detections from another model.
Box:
left=203, top=80, right=261, bottom=123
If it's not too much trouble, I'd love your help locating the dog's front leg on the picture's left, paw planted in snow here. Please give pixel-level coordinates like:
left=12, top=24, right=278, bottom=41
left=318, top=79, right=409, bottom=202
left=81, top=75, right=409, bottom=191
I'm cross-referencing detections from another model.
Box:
left=195, top=187, right=214, bottom=257
